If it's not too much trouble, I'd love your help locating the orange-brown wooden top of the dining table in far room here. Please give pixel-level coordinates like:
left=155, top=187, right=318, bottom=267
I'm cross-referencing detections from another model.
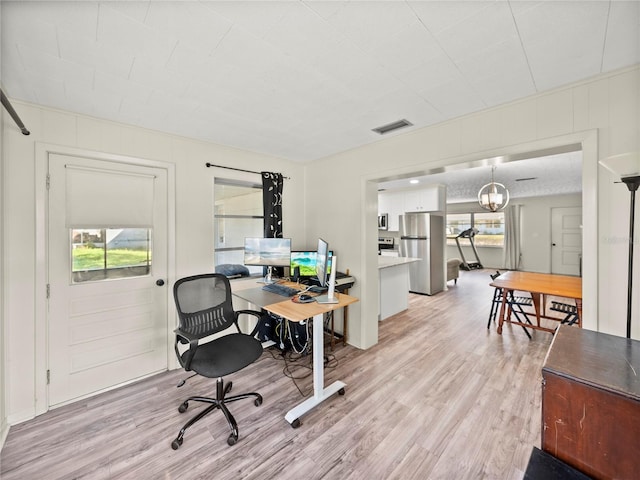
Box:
left=491, top=271, right=582, bottom=299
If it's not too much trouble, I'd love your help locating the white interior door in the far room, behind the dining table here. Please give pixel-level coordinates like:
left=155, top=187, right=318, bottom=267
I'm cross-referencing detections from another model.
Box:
left=551, top=207, right=582, bottom=275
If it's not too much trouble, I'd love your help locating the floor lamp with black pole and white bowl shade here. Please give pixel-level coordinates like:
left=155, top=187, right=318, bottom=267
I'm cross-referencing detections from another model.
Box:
left=599, top=152, right=640, bottom=338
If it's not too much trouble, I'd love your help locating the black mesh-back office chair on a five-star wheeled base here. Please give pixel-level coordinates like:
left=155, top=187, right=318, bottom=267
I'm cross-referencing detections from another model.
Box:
left=171, top=273, right=262, bottom=450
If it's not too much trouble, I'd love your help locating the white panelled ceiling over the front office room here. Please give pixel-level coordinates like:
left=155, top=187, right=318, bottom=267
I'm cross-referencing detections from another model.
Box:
left=0, top=0, right=640, bottom=161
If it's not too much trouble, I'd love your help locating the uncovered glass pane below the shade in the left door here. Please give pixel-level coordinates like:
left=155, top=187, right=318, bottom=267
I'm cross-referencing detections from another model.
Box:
left=71, top=228, right=152, bottom=283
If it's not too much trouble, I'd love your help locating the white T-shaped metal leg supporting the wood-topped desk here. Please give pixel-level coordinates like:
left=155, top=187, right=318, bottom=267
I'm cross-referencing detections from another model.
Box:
left=284, top=314, right=346, bottom=428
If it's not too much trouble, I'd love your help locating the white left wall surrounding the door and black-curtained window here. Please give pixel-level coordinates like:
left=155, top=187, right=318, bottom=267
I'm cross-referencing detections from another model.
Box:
left=2, top=101, right=306, bottom=424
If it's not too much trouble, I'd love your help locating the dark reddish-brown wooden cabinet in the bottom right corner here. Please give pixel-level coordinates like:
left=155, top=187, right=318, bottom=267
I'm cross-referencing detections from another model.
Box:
left=542, top=326, right=640, bottom=479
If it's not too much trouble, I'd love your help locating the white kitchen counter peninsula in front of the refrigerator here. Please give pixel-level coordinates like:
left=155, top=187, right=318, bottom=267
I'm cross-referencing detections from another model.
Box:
left=378, top=255, right=420, bottom=320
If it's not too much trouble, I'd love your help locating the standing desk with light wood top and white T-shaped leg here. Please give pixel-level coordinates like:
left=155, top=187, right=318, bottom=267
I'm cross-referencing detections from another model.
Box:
left=233, top=287, right=358, bottom=428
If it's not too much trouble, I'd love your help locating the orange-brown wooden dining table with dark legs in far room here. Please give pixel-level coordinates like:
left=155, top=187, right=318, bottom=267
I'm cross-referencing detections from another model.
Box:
left=491, top=271, right=582, bottom=334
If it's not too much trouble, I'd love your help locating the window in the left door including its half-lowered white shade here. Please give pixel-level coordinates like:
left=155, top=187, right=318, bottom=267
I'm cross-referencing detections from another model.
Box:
left=65, top=163, right=155, bottom=283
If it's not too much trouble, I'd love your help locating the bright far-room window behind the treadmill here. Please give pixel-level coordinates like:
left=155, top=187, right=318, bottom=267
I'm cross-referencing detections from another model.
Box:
left=447, top=212, right=504, bottom=247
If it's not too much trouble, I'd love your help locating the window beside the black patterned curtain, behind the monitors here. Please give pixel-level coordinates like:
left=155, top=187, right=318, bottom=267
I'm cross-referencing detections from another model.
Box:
left=213, top=178, right=264, bottom=274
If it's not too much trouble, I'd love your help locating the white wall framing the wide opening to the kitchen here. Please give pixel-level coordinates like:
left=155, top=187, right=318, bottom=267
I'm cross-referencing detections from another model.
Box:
left=306, top=66, right=640, bottom=348
